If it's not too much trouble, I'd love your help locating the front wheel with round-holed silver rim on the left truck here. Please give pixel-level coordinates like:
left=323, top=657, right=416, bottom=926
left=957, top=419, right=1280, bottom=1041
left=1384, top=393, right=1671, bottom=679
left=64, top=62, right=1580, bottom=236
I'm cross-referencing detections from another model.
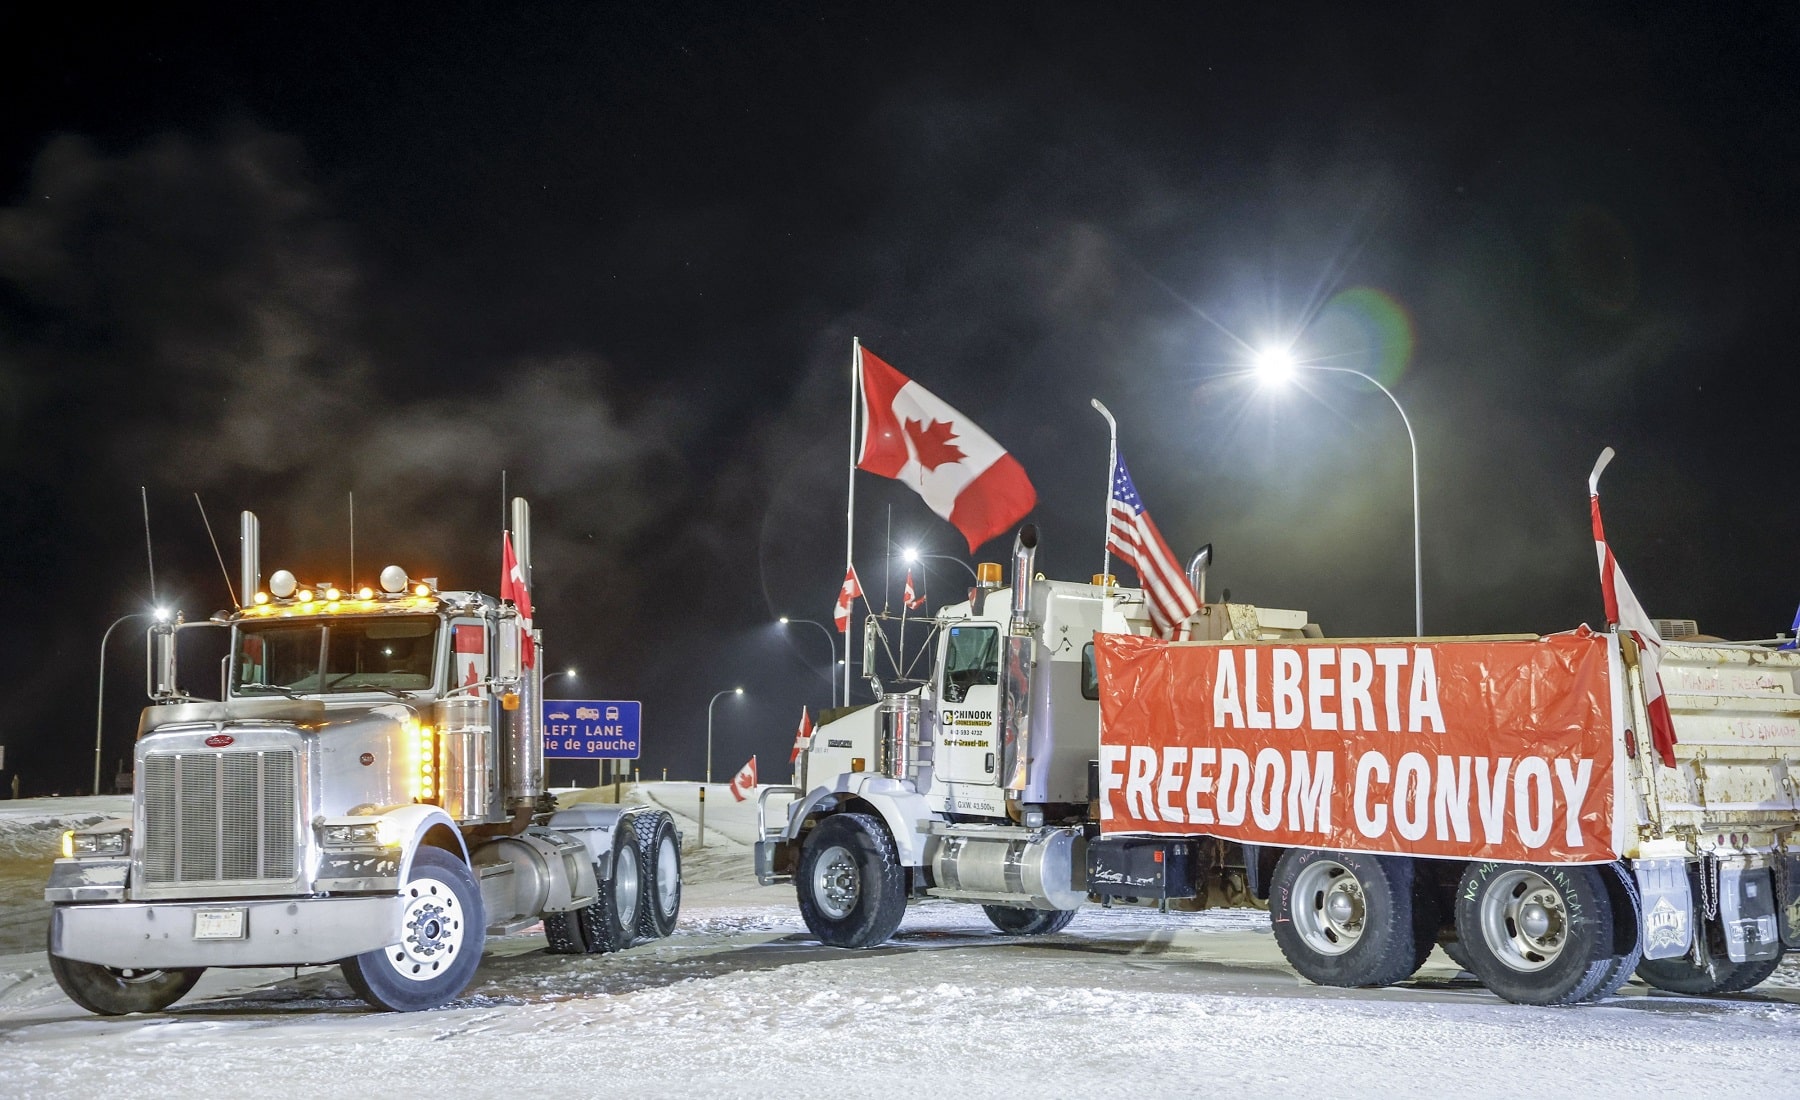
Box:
left=342, top=848, right=488, bottom=1012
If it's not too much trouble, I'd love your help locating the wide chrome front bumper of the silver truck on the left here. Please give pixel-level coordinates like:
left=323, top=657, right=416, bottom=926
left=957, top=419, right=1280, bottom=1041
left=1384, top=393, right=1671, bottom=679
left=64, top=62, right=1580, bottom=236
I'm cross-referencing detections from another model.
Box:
left=50, top=895, right=401, bottom=969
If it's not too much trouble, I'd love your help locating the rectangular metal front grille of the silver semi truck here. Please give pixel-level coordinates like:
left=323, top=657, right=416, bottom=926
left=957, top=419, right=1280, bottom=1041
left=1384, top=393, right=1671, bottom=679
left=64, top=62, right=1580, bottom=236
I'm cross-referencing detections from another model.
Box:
left=137, top=749, right=299, bottom=886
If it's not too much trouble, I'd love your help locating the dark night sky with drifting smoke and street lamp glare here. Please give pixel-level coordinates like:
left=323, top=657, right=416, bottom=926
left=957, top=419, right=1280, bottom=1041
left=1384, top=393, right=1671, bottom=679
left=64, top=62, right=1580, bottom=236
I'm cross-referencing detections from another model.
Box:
left=0, top=4, right=1800, bottom=794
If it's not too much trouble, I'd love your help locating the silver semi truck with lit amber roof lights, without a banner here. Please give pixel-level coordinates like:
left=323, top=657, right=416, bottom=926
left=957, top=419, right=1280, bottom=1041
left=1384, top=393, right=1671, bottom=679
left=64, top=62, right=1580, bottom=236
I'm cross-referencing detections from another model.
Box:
left=45, top=499, right=680, bottom=1015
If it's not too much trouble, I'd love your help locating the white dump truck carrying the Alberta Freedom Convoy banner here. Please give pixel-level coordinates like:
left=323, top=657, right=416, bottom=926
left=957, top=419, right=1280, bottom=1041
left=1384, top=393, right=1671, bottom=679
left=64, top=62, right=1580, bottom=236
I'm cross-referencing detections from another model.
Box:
left=756, top=526, right=1800, bottom=1005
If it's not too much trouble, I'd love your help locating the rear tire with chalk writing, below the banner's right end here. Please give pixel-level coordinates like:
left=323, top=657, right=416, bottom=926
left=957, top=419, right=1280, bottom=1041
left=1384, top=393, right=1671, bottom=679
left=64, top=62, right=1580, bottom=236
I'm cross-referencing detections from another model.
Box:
left=1456, top=862, right=1615, bottom=1005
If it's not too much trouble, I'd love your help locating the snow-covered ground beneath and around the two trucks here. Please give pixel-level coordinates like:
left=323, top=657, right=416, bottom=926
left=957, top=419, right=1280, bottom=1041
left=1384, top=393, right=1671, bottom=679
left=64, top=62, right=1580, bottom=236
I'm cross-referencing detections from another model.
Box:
left=0, top=783, right=1800, bottom=1098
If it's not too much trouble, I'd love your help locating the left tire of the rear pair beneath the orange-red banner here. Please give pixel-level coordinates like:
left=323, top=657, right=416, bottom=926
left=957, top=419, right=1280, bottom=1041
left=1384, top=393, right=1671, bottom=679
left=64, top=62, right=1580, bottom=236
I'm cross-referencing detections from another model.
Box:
left=1269, top=848, right=1429, bottom=987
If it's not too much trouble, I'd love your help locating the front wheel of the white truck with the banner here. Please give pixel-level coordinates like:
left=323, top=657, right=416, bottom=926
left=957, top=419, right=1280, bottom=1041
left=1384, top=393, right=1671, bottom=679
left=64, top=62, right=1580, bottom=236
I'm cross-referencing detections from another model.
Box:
left=794, top=814, right=905, bottom=947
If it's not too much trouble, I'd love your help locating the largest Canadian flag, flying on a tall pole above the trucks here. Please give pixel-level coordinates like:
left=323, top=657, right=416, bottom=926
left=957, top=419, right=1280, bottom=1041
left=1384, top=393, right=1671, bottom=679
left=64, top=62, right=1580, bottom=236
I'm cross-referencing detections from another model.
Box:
left=857, top=346, right=1037, bottom=553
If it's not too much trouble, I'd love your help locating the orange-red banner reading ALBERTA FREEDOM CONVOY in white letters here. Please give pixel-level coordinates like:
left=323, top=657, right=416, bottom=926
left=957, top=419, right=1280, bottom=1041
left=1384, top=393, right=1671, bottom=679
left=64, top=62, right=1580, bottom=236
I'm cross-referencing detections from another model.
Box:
left=1094, top=634, right=1615, bottom=862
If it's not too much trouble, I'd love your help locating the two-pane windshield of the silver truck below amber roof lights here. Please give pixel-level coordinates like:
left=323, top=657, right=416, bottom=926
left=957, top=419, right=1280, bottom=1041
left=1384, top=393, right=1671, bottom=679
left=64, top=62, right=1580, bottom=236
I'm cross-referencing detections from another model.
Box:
left=232, top=616, right=437, bottom=695
